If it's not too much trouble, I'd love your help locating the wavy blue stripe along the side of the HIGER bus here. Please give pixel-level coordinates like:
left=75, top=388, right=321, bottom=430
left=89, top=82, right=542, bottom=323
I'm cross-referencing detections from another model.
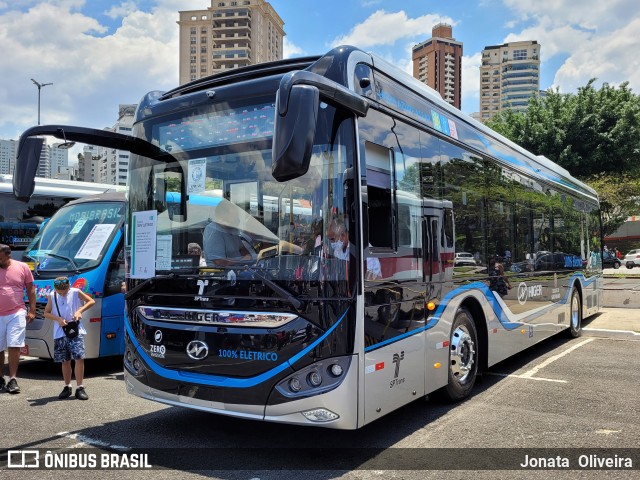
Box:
left=364, top=273, right=597, bottom=352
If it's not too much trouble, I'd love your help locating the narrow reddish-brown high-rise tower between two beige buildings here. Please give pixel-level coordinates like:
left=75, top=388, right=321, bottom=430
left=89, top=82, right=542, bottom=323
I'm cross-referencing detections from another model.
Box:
left=411, top=23, right=462, bottom=108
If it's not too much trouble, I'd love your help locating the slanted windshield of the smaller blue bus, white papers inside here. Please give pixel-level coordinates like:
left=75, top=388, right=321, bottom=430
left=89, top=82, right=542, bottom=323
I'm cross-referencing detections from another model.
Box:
left=25, top=202, right=124, bottom=273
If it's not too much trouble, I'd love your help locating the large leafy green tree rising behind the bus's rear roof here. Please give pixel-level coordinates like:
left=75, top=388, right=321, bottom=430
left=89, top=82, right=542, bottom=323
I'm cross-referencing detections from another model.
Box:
left=487, top=79, right=640, bottom=179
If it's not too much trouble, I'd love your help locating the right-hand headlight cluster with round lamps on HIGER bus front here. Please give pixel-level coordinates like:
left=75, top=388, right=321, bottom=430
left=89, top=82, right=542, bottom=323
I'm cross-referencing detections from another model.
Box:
left=276, top=357, right=351, bottom=398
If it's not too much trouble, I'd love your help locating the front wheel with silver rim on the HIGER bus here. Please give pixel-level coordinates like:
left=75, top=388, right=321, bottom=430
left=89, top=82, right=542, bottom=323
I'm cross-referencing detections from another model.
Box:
left=439, top=307, right=478, bottom=402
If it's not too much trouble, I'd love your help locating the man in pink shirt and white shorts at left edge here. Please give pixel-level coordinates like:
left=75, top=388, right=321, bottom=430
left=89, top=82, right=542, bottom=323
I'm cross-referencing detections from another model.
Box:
left=0, top=244, right=36, bottom=394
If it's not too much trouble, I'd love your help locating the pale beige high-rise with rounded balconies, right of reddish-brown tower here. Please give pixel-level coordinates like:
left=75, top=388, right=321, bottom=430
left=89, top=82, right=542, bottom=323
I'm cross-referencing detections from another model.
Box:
left=480, top=40, right=540, bottom=122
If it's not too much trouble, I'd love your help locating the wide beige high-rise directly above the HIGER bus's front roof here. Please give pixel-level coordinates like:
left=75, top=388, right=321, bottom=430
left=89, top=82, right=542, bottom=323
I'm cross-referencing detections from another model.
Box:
left=178, top=0, right=285, bottom=84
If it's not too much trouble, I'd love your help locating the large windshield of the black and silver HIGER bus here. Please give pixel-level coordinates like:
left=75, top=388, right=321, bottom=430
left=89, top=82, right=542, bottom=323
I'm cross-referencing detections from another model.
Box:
left=128, top=92, right=355, bottom=280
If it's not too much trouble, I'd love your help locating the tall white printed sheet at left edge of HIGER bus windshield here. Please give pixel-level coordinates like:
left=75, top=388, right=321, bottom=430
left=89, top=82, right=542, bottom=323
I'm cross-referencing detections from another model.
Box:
left=131, top=210, right=158, bottom=278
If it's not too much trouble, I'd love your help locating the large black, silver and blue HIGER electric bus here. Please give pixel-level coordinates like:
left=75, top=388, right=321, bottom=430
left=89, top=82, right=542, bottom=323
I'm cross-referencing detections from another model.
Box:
left=16, top=46, right=602, bottom=429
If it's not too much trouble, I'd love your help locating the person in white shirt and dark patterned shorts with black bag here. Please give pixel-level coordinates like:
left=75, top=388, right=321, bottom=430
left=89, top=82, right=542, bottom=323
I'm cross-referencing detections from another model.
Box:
left=44, top=277, right=96, bottom=400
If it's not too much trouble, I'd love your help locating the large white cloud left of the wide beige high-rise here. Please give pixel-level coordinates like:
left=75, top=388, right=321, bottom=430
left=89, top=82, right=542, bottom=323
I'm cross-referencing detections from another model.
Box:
left=0, top=1, right=182, bottom=138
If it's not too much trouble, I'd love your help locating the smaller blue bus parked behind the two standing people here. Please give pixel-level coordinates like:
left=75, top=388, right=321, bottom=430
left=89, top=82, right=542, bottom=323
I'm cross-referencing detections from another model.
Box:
left=22, top=192, right=125, bottom=359
